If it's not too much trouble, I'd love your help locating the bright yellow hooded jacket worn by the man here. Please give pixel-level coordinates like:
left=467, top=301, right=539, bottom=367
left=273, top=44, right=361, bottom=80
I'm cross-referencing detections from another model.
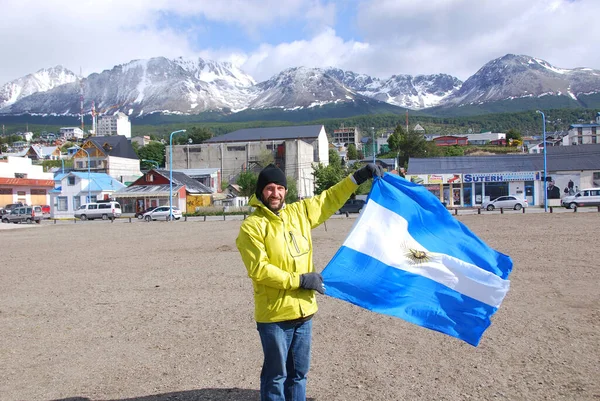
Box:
left=236, top=177, right=357, bottom=323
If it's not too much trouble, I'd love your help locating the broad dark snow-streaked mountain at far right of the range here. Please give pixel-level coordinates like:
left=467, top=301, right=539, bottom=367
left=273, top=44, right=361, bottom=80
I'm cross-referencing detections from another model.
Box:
left=445, top=54, right=600, bottom=105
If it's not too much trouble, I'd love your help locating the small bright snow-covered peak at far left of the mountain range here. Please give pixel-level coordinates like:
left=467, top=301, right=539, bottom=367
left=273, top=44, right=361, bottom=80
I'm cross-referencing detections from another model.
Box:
left=0, top=65, right=77, bottom=109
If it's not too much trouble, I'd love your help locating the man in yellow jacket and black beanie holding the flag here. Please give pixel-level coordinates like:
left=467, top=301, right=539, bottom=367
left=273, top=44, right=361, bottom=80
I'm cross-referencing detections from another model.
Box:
left=236, top=164, right=383, bottom=401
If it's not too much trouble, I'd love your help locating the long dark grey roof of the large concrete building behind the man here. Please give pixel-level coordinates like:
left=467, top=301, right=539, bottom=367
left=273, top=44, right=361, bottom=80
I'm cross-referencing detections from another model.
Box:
left=205, top=125, right=323, bottom=143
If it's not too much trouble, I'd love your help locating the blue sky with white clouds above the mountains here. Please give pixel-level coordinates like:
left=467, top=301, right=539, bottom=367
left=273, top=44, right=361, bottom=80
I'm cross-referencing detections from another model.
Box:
left=0, top=0, right=600, bottom=85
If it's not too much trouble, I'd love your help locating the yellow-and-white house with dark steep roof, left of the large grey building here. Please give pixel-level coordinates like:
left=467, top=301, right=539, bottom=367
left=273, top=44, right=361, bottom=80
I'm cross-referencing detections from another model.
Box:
left=73, top=135, right=142, bottom=183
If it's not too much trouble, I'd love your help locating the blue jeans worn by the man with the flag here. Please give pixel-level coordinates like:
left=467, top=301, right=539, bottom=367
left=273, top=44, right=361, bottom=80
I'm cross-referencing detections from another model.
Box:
left=256, top=319, right=312, bottom=401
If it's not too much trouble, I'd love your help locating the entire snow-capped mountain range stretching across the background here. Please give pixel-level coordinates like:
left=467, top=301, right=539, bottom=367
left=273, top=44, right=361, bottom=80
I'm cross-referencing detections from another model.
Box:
left=0, top=54, right=600, bottom=117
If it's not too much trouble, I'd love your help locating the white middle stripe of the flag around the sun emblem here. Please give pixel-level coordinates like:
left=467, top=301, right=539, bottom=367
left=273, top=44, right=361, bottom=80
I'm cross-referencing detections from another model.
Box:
left=344, top=199, right=510, bottom=307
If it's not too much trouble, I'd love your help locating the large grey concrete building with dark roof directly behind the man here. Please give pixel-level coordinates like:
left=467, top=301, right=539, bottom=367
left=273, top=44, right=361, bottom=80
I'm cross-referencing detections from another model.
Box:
left=166, top=125, right=329, bottom=197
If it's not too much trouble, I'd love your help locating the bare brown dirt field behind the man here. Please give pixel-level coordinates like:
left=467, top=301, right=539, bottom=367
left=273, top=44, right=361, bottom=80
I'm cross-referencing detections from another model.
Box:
left=0, top=213, right=600, bottom=401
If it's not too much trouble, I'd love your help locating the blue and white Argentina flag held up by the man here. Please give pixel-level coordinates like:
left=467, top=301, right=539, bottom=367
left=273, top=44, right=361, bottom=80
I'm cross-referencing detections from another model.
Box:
left=322, top=174, right=512, bottom=346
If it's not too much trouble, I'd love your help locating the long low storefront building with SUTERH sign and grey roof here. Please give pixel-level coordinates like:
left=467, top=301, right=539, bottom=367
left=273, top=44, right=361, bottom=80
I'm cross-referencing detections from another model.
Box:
left=406, top=145, right=600, bottom=206
